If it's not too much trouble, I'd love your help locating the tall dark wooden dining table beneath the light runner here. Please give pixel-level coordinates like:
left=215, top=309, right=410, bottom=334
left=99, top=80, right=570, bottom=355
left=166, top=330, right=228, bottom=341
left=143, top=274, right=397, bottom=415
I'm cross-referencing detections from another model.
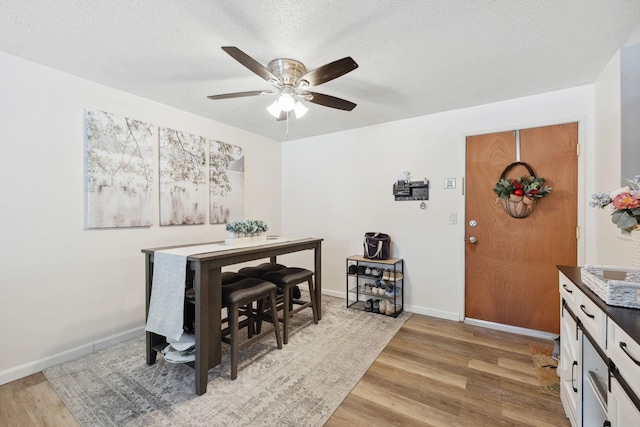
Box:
left=142, top=238, right=323, bottom=395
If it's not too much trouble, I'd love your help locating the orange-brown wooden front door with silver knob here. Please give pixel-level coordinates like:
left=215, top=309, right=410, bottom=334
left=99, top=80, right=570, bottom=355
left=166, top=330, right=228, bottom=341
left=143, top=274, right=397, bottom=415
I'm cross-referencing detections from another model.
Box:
left=465, top=123, right=578, bottom=333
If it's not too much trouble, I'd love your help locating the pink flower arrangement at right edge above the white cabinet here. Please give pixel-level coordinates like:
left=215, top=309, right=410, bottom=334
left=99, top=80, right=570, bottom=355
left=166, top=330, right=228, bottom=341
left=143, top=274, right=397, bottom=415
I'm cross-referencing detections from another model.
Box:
left=589, top=175, right=640, bottom=231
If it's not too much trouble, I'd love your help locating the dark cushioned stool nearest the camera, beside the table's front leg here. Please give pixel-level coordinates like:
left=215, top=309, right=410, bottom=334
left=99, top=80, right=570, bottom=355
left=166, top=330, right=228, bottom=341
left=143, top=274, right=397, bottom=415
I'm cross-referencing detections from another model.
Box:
left=222, top=278, right=282, bottom=380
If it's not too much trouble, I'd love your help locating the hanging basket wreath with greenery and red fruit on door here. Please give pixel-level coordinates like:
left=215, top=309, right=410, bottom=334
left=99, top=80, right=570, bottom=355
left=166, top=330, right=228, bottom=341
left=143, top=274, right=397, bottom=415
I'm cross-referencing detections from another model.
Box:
left=493, top=162, right=551, bottom=218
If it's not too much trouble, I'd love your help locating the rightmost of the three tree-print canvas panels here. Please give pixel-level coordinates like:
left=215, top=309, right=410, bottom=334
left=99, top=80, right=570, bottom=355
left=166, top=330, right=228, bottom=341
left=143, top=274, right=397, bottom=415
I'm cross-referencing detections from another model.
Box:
left=209, top=141, right=244, bottom=224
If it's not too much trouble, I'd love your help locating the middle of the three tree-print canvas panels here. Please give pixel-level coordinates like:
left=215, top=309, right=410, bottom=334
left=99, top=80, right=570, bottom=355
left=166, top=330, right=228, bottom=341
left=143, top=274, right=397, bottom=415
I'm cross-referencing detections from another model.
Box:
left=158, top=128, right=208, bottom=225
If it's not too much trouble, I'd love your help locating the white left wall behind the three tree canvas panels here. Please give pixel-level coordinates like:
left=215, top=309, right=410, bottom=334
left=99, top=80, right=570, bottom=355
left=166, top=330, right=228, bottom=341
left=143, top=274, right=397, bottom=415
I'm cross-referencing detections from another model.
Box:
left=0, top=53, right=281, bottom=384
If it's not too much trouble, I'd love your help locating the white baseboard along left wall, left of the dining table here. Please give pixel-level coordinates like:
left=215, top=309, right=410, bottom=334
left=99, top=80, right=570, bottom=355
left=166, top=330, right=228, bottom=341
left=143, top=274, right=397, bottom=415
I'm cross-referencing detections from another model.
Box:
left=0, top=326, right=144, bottom=385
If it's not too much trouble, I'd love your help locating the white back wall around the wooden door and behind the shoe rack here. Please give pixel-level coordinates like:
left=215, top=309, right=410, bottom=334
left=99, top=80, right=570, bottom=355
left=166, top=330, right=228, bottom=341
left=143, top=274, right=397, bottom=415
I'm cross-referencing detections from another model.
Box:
left=282, top=85, right=594, bottom=319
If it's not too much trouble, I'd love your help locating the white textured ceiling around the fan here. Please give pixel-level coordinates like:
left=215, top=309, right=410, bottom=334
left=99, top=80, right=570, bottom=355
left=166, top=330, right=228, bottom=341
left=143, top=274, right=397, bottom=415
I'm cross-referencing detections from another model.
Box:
left=0, top=0, right=640, bottom=141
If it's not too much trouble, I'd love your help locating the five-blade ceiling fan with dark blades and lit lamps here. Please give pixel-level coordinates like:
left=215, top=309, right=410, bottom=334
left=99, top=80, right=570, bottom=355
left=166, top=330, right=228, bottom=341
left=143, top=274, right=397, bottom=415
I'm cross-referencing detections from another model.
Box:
left=207, top=46, right=358, bottom=120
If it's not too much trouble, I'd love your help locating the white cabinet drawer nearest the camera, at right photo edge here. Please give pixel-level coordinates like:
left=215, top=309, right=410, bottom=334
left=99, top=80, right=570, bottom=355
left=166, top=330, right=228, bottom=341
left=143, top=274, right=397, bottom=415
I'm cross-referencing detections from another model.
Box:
left=608, top=322, right=640, bottom=396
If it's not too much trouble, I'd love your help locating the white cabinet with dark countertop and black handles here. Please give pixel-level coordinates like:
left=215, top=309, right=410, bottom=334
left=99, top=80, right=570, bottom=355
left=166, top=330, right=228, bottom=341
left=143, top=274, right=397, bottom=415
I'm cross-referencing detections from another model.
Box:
left=558, top=266, right=640, bottom=427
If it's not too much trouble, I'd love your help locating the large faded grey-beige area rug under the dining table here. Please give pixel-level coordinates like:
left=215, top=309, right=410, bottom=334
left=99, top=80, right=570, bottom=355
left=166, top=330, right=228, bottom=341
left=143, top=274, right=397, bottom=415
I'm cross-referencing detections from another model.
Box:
left=44, top=296, right=410, bottom=426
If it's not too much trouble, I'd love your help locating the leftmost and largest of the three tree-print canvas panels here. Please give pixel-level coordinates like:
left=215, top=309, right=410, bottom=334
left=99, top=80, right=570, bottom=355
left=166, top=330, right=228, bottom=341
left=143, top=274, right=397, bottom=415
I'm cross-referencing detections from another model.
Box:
left=85, top=110, right=154, bottom=228
